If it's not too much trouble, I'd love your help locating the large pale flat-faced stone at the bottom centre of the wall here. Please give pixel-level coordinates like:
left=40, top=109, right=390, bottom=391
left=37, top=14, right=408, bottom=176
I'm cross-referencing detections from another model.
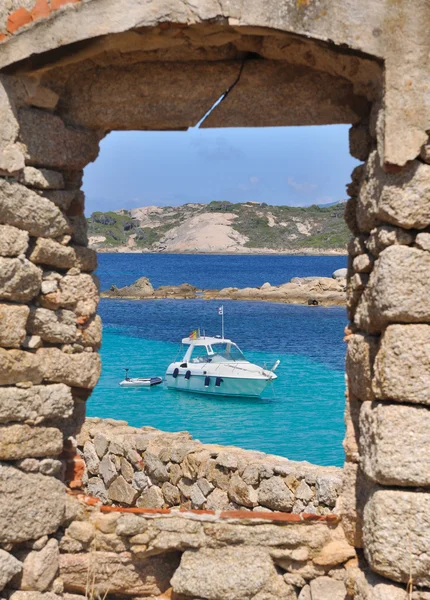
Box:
left=171, top=546, right=275, bottom=600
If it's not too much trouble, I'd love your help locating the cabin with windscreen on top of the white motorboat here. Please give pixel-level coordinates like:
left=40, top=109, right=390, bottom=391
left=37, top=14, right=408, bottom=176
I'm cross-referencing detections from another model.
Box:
left=178, top=336, right=246, bottom=363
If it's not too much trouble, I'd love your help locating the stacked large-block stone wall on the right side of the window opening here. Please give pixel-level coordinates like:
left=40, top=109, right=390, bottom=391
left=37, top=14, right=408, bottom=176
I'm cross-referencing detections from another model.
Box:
left=342, top=114, right=430, bottom=600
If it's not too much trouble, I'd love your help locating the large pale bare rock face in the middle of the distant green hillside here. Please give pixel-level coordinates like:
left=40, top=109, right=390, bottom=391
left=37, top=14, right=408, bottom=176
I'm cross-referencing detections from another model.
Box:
left=158, top=213, right=248, bottom=252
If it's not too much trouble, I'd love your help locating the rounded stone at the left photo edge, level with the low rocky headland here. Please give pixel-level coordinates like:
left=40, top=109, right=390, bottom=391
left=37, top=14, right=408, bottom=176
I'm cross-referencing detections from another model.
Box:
left=0, top=258, right=42, bottom=302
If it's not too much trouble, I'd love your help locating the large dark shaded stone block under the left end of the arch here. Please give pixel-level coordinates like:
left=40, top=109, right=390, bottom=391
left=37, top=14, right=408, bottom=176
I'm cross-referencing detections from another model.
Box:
left=19, top=109, right=99, bottom=170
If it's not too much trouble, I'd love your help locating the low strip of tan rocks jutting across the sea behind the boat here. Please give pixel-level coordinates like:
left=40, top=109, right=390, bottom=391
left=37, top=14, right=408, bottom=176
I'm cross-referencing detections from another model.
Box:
left=101, top=269, right=346, bottom=306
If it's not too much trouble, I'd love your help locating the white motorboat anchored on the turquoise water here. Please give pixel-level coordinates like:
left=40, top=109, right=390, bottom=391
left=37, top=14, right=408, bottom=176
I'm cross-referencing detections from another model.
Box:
left=165, top=330, right=279, bottom=397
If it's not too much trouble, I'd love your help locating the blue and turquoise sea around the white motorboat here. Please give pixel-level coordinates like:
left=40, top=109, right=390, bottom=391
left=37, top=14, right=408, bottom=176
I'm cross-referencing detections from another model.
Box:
left=87, top=254, right=346, bottom=466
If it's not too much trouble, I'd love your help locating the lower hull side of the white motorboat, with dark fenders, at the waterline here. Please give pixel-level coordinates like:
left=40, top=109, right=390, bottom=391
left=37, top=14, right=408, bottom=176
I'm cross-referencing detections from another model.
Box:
left=165, top=373, right=270, bottom=398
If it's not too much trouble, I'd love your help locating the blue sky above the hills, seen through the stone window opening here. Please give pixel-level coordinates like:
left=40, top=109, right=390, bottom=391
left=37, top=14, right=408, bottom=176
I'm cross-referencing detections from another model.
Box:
left=84, top=125, right=358, bottom=215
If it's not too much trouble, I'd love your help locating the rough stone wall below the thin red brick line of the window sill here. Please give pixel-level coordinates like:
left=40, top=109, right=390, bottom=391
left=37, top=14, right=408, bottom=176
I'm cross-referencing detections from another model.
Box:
left=58, top=498, right=358, bottom=600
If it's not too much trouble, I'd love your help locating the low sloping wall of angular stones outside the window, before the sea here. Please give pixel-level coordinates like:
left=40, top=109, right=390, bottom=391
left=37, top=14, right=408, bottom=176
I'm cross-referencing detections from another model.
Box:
left=76, top=419, right=342, bottom=515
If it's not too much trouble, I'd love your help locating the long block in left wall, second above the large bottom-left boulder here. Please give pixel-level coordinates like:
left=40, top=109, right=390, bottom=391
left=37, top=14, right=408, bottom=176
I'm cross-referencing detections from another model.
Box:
left=0, top=383, right=73, bottom=425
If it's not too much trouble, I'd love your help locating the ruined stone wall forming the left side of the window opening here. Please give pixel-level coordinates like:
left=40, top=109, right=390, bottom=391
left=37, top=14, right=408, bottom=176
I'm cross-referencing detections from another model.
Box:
left=0, top=76, right=101, bottom=592
